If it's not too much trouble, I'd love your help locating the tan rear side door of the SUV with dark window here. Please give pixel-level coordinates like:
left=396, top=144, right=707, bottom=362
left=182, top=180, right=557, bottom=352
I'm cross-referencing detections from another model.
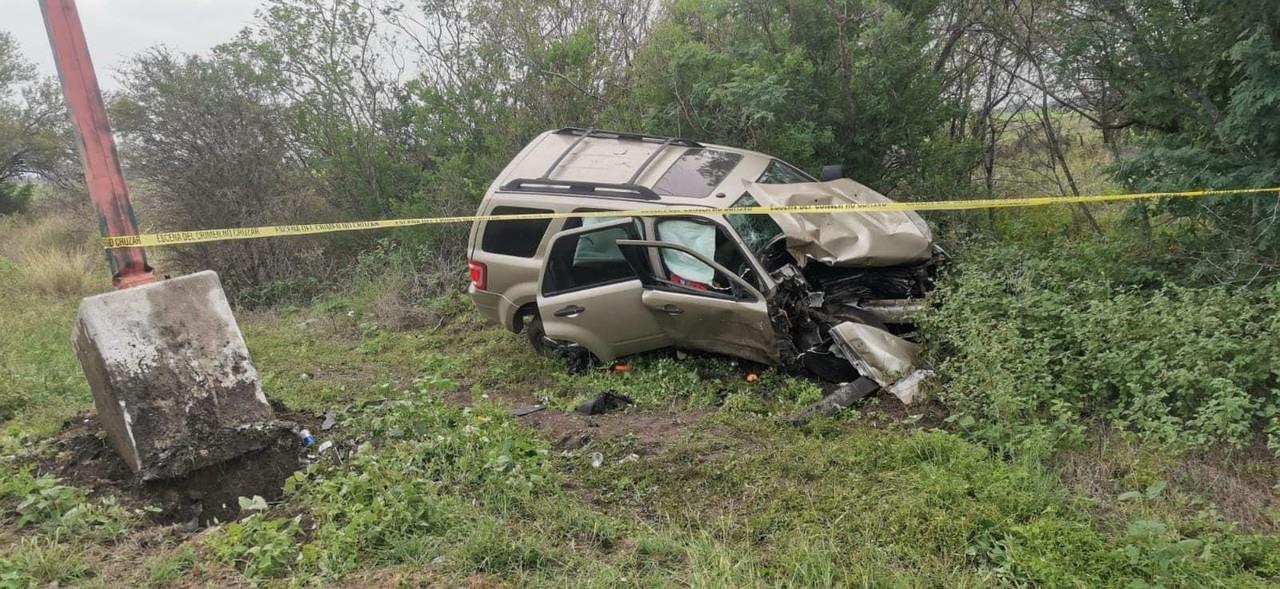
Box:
left=538, top=219, right=669, bottom=362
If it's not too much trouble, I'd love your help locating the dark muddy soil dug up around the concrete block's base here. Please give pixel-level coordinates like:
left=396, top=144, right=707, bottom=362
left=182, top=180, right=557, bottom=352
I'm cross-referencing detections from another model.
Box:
left=36, top=407, right=315, bottom=530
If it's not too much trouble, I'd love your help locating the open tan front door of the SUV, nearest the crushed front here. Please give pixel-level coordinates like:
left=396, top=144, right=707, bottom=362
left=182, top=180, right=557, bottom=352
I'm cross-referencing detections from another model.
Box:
left=617, top=239, right=780, bottom=365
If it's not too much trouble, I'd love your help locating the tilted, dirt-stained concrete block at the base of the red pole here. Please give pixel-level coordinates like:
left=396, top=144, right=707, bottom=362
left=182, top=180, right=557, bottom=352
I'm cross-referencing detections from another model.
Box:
left=72, top=271, right=279, bottom=480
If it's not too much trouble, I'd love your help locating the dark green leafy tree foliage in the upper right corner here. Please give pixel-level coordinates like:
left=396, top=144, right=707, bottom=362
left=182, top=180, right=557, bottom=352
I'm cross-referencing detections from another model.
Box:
left=1100, top=0, right=1280, bottom=271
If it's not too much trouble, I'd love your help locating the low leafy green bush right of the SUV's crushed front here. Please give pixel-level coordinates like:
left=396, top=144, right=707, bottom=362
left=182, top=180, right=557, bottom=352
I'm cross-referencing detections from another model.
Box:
left=925, top=243, right=1280, bottom=449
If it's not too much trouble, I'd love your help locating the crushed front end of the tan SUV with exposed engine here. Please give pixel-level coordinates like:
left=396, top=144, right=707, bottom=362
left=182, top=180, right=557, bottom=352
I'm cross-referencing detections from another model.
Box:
left=726, top=179, right=942, bottom=403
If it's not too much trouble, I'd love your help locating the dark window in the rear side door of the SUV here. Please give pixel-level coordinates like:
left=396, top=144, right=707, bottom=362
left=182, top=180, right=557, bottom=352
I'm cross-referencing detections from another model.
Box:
left=543, top=223, right=640, bottom=297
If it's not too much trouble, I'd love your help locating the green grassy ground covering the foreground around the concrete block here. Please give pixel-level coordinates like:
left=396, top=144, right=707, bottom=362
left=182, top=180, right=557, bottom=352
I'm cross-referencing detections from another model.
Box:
left=0, top=238, right=1280, bottom=588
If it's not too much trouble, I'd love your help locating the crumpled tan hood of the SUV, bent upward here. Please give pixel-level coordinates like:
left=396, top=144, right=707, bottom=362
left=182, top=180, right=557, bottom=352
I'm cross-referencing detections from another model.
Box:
left=745, top=178, right=933, bottom=268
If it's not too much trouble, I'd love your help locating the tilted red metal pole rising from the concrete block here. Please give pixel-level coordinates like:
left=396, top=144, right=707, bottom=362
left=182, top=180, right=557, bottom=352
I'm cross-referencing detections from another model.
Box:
left=40, top=0, right=155, bottom=288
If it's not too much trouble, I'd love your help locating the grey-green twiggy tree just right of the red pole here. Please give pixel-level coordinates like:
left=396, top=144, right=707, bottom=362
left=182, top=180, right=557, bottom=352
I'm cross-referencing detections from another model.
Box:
left=111, top=47, right=332, bottom=297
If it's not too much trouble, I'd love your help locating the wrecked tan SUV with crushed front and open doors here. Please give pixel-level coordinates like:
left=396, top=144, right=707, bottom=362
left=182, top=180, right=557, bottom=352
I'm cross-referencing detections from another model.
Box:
left=467, top=128, right=936, bottom=401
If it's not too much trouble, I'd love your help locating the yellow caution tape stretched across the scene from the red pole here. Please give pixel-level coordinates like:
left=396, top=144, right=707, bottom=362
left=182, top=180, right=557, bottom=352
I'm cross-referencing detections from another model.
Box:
left=102, top=187, right=1280, bottom=250
